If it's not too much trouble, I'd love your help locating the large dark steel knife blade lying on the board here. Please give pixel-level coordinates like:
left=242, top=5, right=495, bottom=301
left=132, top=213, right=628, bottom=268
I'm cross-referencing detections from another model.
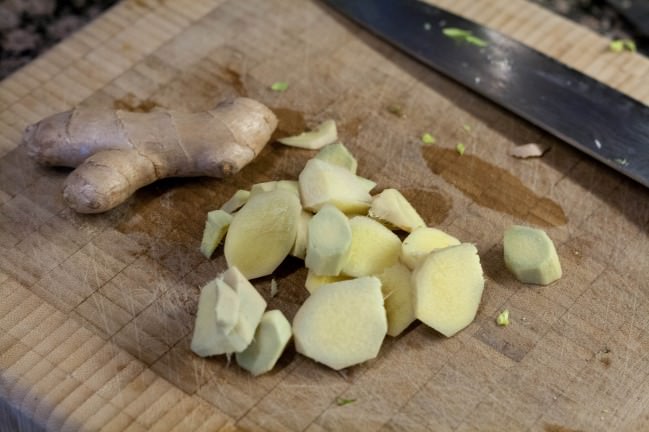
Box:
left=325, top=0, right=649, bottom=187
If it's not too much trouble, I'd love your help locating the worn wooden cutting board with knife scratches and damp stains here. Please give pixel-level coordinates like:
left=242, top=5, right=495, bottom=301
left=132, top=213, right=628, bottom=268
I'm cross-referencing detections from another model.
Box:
left=0, top=0, right=649, bottom=432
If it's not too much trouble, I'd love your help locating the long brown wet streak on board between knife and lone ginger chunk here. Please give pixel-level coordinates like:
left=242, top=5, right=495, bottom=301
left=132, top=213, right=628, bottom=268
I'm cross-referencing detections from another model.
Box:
left=422, top=146, right=568, bottom=227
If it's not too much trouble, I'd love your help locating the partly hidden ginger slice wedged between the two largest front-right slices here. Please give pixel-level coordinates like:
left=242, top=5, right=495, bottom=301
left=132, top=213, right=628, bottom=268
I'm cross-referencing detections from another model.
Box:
left=378, top=263, right=415, bottom=336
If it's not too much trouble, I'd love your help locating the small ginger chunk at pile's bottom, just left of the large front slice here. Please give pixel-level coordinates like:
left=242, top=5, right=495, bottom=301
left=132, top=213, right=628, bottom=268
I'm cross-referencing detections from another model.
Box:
left=235, top=310, right=293, bottom=376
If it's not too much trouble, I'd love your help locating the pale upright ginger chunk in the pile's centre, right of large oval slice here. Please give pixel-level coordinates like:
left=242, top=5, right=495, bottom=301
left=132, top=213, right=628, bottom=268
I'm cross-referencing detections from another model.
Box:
left=304, top=204, right=352, bottom=276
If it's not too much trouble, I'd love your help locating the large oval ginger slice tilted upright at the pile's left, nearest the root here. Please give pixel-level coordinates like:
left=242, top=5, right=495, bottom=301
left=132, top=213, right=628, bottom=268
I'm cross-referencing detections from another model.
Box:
left=223, top=189, right=301, bottom=279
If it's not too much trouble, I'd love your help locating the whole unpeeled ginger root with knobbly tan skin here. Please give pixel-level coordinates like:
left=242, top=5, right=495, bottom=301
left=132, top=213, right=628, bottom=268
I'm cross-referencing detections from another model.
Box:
left=24, top=98, right=277, bottom=213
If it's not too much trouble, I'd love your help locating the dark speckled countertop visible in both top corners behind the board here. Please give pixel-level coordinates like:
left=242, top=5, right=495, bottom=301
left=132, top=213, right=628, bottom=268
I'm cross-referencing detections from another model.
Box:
left=0, top=0, right=649, bottom=79
